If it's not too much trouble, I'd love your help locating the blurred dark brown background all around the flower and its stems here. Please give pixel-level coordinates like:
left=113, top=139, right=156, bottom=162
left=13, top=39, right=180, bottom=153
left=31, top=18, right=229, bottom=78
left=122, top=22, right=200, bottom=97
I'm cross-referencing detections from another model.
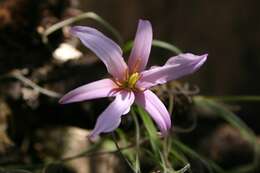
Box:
left=0, top=0, right=260, bottom=173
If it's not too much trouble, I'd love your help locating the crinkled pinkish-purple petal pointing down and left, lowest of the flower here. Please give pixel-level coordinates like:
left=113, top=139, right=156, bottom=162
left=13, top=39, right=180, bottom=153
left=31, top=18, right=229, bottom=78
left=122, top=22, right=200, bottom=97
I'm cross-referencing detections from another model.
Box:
left=89, top=91, right=135, bottom=140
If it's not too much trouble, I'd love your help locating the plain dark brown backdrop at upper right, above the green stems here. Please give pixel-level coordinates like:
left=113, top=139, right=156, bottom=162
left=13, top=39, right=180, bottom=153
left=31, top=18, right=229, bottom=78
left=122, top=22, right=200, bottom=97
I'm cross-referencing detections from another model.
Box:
left=82, top=0, right=260, bottom=95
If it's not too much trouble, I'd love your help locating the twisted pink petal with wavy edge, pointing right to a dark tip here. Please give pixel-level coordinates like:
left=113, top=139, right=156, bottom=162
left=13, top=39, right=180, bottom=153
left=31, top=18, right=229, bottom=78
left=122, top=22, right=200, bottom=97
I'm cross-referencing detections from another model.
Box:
left=137, top=53, right=208, bottom=88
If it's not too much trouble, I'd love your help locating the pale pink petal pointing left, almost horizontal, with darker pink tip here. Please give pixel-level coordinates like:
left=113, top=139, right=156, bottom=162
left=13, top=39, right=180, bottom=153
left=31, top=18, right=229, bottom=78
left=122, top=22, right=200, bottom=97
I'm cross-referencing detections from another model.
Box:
left=59, top=79, right=117, bottom=104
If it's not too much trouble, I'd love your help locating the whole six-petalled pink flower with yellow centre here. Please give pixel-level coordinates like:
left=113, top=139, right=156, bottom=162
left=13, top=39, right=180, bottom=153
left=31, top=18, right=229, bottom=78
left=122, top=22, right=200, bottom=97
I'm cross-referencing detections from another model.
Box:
left=60, top=20, right=207, bottom=139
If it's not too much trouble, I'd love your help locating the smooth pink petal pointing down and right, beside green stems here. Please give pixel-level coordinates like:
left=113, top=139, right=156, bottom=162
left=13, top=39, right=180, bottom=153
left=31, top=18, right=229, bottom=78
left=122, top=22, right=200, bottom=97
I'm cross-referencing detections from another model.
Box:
left=135, top=90, right=171, bottom=135
